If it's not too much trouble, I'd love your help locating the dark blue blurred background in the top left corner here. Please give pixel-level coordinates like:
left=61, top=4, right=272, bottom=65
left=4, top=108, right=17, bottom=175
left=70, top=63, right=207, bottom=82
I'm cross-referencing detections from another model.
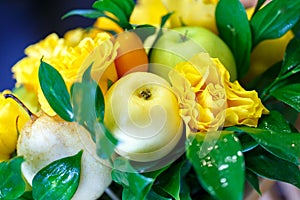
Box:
left=0, top=0, right=94, bottom=92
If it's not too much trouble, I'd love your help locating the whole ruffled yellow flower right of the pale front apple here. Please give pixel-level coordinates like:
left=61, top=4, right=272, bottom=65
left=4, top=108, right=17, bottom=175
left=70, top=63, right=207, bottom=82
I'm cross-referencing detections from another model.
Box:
left=169, top=53, right=268, bottom=134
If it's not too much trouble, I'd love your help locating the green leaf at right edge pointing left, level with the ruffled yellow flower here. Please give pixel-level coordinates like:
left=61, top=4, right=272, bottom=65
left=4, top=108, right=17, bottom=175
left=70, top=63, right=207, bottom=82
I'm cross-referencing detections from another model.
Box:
left=270, top=83, right=300, bottom=112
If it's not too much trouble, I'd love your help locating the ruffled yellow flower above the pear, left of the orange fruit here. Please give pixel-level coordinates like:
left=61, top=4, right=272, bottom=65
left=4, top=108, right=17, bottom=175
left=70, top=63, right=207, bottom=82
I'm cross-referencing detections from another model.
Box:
left=12, top=29, right=118, bottom=116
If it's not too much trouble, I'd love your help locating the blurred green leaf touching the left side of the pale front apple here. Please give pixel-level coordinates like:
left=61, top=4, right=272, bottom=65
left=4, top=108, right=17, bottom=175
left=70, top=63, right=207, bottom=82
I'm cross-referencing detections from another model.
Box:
left=72, top=64, right=118, bottom=159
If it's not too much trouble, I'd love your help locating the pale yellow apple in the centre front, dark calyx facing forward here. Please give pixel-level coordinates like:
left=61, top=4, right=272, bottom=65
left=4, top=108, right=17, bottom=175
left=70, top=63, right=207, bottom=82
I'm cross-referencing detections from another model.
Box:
left=104, top=72, right=183, bottom=162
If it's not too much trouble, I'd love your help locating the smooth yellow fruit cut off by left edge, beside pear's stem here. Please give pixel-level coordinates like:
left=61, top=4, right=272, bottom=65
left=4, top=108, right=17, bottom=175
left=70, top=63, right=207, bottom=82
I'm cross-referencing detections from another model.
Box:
left=0, top=90, right=30, bottom=161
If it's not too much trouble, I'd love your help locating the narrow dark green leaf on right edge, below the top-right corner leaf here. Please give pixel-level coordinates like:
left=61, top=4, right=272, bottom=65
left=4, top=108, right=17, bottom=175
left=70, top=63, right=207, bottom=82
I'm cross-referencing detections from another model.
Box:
left=279, top=38, right=300, bottom=75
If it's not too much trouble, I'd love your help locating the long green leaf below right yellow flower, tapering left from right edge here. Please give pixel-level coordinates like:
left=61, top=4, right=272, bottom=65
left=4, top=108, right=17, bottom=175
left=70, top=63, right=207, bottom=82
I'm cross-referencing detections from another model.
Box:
left=230, top=127, right=300, bottom=165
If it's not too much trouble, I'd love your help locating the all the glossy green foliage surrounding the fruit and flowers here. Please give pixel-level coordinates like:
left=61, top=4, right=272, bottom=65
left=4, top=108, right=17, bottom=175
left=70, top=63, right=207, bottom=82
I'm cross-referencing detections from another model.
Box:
left=0, top=0, right=300, bottom=200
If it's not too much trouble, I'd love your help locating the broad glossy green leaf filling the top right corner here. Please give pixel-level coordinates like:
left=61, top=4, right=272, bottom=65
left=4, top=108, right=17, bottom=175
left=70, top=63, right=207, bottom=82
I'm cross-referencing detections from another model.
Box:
left=250, top=0, right=300, bottom=48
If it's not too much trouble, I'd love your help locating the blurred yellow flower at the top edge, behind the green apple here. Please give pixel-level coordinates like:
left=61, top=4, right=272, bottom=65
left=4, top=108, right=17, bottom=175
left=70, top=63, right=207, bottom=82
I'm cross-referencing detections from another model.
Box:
left=161, top=0, right=219, bottom=33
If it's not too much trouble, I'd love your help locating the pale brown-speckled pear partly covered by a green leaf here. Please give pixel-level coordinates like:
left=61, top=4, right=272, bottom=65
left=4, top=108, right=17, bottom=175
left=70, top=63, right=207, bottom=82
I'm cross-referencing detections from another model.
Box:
left=17, top=114, right=112, bottom=200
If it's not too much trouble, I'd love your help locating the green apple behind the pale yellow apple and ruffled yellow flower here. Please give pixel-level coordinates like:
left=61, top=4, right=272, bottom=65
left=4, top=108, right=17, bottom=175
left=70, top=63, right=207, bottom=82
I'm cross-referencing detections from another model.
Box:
left=149, top=26, right=237, bottom=81
